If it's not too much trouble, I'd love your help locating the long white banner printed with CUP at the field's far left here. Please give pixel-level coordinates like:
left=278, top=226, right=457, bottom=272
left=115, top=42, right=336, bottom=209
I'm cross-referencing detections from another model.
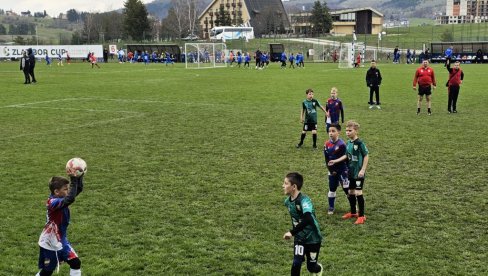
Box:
left=0, top=45, right=103, bottom=58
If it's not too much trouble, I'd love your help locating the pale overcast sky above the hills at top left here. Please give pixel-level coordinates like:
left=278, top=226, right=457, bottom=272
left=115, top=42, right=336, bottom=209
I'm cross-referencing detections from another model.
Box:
left=0, top=0, right=153, bottom=17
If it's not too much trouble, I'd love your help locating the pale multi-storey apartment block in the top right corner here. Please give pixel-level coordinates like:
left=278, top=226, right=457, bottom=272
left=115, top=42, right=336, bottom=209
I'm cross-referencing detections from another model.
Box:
left=436, top=0, right=488, bottom=24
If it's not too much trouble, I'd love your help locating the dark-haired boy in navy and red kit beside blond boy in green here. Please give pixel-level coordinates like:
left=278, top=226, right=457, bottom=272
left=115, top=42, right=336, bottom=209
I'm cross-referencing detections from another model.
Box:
left=324, top=124, right=349, bottom=215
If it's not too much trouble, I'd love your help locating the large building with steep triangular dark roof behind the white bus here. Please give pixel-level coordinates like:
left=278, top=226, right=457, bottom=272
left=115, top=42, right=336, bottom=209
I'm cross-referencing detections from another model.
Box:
left=198, top=0, right=290, bottom=38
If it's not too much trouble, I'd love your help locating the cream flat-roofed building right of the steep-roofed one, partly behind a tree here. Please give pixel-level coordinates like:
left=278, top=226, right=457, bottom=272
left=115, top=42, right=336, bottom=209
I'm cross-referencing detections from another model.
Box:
left=289, top=7, right=384, bottom=35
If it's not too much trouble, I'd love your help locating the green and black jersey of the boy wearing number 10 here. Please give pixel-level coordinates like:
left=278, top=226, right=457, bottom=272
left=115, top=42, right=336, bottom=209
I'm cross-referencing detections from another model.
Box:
left=285, top=193, right=322, bottom=244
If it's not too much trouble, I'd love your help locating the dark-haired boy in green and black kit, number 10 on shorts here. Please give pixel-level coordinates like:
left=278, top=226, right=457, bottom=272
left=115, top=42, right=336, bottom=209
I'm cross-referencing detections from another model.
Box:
left=282, top=172, right=323, bottom=276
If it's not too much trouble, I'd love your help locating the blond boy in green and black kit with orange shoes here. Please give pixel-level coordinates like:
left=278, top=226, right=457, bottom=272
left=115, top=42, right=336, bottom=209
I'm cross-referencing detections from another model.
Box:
left=342, top=121, right=369, bottom=224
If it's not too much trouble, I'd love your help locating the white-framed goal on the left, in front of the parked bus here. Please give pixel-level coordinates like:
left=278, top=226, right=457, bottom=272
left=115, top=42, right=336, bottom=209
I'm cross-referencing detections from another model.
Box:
left=185, top=43, right=227, bottom=69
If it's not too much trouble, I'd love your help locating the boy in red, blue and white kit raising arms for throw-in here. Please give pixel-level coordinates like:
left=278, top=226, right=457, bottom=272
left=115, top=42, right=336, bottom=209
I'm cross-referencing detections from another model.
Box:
left=36, top=172, right=83, bottom=276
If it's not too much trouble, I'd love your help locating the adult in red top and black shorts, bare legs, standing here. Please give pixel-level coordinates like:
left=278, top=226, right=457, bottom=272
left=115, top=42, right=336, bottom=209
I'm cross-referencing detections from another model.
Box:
left=413, top=59, right=436, bottom=115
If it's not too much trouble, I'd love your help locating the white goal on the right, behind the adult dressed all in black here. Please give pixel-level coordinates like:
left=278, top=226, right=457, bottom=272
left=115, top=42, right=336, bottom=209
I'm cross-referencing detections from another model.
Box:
left=339, top=42, right=377, bottom=68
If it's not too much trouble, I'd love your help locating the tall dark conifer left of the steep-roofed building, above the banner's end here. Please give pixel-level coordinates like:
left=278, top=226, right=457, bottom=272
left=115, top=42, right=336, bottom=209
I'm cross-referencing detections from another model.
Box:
left=124, top=0, right=151, bottom=41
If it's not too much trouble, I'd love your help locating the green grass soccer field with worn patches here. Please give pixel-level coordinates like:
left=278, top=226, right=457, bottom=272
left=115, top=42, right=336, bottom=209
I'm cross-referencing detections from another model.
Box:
left=0, top=59, right=488, bottom=275
